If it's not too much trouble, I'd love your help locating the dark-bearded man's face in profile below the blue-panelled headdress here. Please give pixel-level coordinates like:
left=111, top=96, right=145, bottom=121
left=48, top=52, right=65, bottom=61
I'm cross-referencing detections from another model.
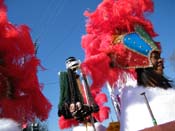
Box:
left=150, top=51, right=164, bottom=75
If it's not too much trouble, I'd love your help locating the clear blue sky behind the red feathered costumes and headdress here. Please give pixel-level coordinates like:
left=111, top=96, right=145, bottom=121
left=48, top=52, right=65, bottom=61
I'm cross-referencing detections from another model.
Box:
left=5, top=0, right=175, bottom=131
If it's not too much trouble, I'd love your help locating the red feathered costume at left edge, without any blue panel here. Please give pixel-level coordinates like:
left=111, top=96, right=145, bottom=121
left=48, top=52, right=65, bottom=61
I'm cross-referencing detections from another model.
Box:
left=0, top=0, right=51, bottom=123
